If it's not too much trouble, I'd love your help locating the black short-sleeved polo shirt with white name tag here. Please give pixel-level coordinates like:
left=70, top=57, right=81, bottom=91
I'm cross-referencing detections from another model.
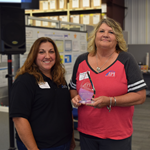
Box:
left=10, top=73, right=72, bottom=148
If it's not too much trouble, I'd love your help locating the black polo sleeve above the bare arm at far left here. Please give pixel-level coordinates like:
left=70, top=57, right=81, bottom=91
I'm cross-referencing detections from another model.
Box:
left=9, top=76, right=35, bottom=119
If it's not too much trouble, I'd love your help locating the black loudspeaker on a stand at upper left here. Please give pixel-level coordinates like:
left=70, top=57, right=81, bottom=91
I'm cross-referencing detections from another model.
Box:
left=0, top=6, right=26, bottom=54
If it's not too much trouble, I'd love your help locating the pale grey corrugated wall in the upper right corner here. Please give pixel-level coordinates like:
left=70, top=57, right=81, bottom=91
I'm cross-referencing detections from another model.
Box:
left=125, top=0, right=150, bottom=44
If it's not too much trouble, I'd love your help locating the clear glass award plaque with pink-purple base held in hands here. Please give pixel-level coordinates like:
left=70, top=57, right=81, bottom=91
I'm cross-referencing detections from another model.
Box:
left=79, top=71, right=95, bottom=104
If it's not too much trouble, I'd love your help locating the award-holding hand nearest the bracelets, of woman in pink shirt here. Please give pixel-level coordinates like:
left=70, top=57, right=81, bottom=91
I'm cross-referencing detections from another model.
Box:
left=86, top=96, right=110, bottom=108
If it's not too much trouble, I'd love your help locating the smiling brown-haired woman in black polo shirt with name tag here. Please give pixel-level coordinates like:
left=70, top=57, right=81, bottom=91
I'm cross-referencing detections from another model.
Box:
left=10, top=37, right=75, bottom=150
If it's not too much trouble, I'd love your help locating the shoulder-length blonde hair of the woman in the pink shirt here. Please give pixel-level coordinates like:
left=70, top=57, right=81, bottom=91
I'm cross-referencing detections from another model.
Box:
left=88, top=17, right=128, bottom=55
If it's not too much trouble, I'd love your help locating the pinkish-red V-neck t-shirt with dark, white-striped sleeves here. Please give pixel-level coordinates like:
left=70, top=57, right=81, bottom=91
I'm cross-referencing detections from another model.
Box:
left=70, top=52, right=146, bottom=140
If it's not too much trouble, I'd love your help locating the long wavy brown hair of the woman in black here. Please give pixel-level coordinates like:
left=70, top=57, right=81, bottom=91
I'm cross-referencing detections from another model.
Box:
left=15, top=37, right=65, bottom=86
